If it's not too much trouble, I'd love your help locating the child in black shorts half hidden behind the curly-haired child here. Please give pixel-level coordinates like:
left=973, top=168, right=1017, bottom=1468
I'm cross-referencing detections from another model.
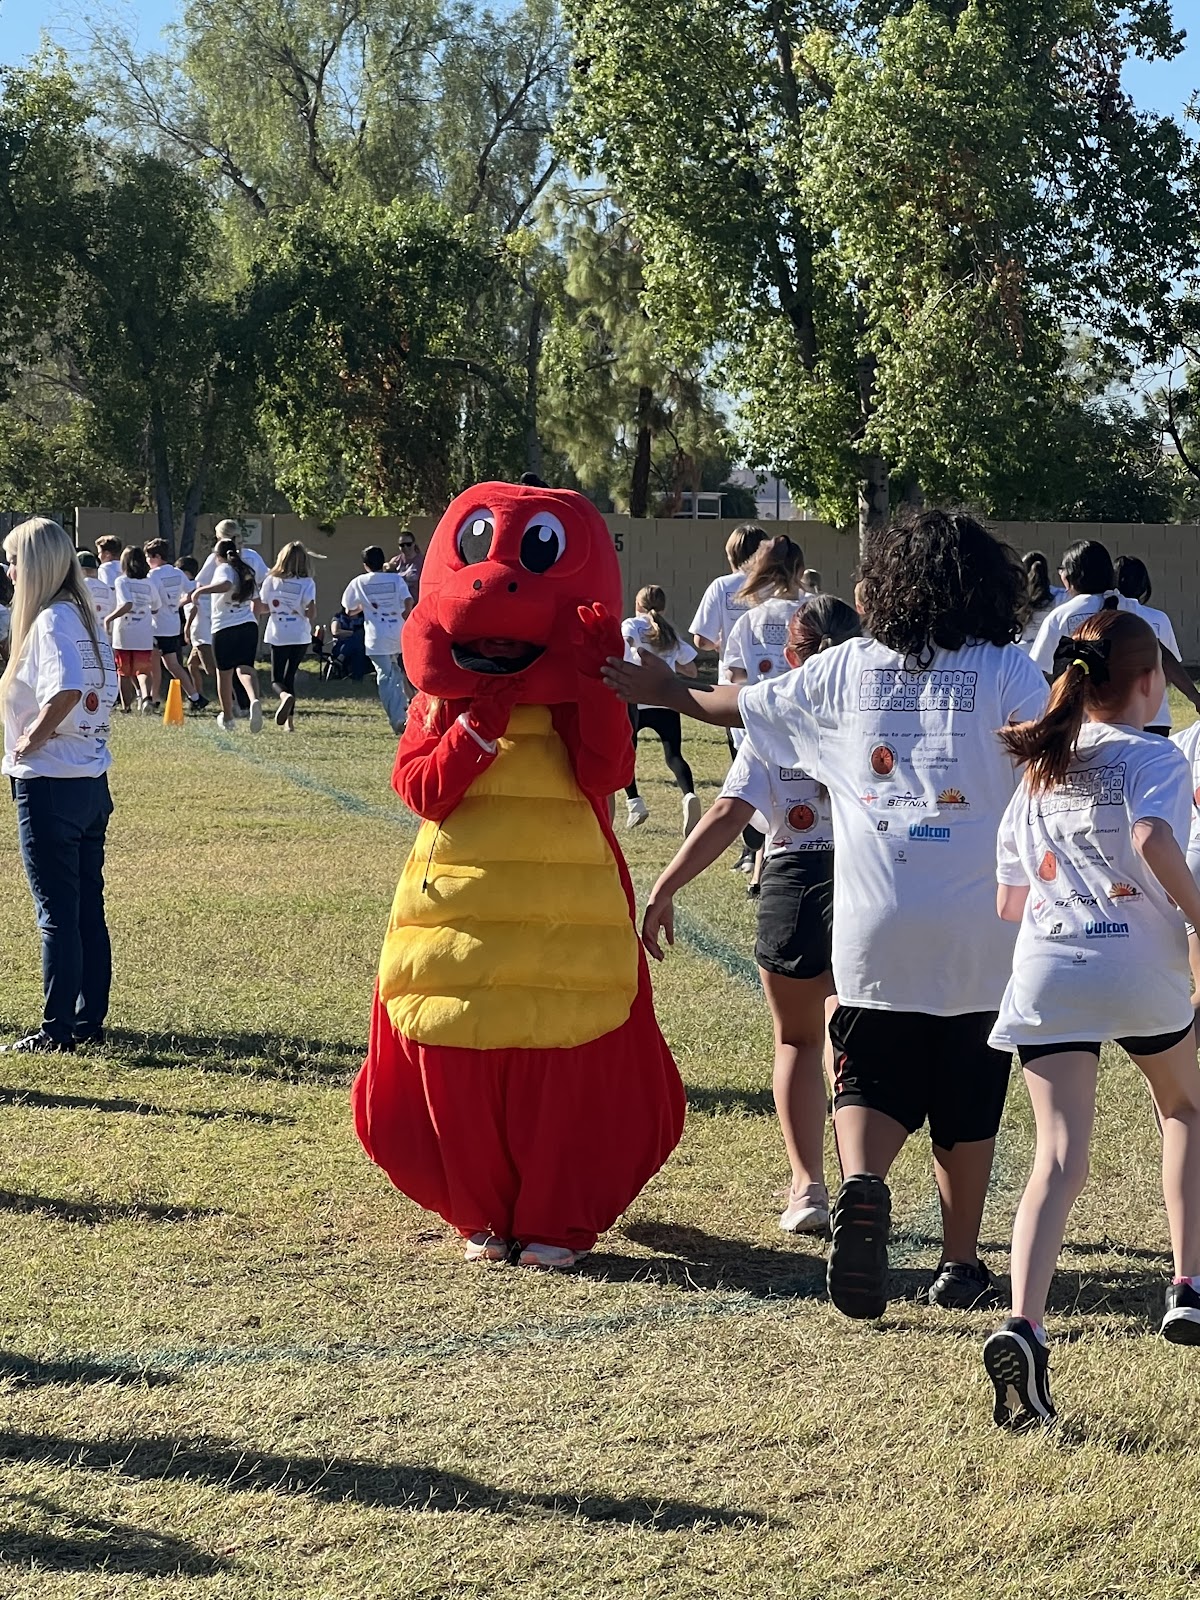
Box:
left=642, top=595, right=862, bottom=1234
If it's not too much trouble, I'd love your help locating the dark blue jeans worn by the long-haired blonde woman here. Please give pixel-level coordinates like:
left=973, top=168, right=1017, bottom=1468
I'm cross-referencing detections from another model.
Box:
left=13, top=776, right=112, bottom=1043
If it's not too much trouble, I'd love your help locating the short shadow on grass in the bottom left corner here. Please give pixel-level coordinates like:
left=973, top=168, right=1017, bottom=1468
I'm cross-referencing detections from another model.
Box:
left=0, top=1494, right=230, bottom=1578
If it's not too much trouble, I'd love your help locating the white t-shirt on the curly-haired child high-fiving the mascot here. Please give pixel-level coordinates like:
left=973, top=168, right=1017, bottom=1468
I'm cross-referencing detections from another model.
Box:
left=738, top=638, right=1048, bottom=1016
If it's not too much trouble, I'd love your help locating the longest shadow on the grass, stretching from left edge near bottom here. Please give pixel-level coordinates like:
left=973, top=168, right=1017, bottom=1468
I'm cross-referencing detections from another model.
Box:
left=0, top=1432, right=766, bottom=1531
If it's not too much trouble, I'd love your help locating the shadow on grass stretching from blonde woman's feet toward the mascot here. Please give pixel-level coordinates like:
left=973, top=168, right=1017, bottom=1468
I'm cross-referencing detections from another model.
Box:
left=106, top=1030, right=366, bottom=1083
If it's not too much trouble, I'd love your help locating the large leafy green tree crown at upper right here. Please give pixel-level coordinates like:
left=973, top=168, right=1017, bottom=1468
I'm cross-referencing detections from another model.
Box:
left=565, top=0, right=1197, bottom=540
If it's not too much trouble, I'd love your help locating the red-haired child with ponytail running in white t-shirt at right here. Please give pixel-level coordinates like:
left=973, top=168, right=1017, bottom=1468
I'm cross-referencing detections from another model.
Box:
left=984, top=611, right=1200, bottom=1427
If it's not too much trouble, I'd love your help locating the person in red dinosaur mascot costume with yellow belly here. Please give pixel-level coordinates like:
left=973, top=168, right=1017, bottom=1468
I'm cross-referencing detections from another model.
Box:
left=354, top=483, right=685, bottom=1267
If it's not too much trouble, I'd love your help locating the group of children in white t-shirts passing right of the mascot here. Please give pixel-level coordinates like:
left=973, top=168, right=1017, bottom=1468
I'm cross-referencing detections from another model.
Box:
left=605, top=512, right=1200, bottom=1427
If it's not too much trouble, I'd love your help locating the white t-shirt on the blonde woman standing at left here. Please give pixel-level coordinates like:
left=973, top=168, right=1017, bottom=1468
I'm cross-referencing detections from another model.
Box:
left=3, top=600, right=117, bottom=778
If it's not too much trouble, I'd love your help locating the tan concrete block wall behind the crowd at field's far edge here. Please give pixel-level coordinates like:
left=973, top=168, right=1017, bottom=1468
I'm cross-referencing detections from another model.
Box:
left=77, top=509, right=1200, bottom=662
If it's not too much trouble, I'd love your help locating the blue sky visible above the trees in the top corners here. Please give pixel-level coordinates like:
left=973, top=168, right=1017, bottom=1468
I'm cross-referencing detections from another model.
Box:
left=0, top=0, right=1200, bottom=112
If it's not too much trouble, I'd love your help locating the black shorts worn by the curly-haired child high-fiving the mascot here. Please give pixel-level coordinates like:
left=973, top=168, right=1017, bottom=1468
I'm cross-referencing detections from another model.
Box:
left=829, top=1005, right=1013, bottom=1150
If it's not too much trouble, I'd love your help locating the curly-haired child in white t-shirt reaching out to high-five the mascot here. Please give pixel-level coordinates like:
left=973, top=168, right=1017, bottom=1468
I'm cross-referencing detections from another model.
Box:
left=605, top=510, right=1046, bottom=1317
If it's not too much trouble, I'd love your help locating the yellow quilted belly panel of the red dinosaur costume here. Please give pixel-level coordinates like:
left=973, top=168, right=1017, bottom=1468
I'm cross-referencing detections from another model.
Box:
left=379, top=706, right=637, bottom=1050
